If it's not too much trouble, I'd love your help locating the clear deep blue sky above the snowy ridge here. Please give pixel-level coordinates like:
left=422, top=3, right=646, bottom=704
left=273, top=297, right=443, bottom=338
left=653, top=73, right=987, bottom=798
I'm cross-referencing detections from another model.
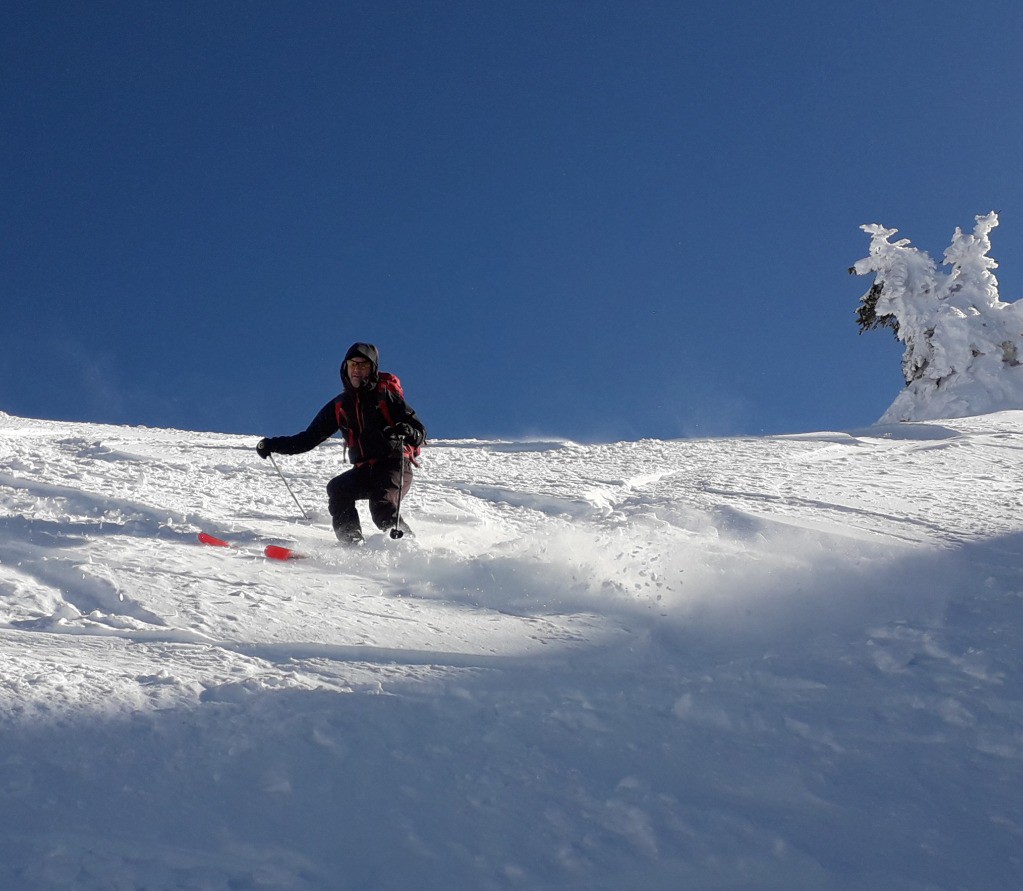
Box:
left=0, top=0, right=1023, bottom=440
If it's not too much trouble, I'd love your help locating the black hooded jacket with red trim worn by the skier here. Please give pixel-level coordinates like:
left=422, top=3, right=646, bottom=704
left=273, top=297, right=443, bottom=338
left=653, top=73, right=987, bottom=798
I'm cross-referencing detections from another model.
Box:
left=267, top=344, right=427, bottom=465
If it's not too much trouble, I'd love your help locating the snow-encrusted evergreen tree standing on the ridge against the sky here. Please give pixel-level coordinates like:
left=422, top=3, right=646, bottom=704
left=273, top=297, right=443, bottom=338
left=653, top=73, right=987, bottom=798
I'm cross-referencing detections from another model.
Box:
left=850, top=212, right=1023, bottom=424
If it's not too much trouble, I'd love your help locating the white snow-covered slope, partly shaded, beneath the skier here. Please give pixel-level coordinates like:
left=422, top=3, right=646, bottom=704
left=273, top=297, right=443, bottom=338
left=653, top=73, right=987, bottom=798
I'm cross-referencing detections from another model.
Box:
left=0, top=411, right=1023, bottom=891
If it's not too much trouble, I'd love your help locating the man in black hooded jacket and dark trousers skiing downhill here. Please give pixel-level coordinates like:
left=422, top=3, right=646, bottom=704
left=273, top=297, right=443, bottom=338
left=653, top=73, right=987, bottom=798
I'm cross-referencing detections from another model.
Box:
left=256, top=344, right=427, bottom=544
